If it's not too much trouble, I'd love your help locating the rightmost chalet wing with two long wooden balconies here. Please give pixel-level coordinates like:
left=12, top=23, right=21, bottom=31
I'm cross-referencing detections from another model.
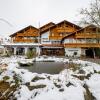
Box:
left=62, top=25, right=100, bottom=57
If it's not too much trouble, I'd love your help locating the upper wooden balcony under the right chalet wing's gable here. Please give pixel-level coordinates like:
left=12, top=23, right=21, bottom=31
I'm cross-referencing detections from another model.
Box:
left=76, top=33, right=100, bottom=38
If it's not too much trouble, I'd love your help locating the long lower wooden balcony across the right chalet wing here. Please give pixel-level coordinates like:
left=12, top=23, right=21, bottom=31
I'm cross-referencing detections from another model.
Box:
left=64, top=43, right=100, bottom=48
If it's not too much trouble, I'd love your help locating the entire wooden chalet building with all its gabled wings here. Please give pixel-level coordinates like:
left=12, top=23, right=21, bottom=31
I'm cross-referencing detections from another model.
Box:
left=1, top=20, right=100, bottom=56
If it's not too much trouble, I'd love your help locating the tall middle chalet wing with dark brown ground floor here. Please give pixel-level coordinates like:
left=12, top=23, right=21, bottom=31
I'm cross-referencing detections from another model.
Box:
left=40, top=20, right=81, bottom=56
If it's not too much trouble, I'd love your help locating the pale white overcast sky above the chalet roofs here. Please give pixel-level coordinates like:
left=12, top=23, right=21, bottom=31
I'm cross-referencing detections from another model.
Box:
left=0, top=0, right=90, bottom=35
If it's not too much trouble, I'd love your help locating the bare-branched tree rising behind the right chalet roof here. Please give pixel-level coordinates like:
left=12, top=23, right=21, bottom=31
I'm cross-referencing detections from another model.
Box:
left=80, top=0, right=100, bottom=27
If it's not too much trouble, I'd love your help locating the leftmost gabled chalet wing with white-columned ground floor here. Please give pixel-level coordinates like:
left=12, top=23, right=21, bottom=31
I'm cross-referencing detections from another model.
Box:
left=2, top=25, right=40, bottom=55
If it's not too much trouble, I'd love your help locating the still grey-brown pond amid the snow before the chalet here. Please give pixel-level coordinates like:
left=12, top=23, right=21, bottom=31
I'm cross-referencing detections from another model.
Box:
left=23, top=62, right=64, bottom=74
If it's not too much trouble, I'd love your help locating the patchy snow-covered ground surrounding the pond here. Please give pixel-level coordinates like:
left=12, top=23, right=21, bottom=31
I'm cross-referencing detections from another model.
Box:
left=0, top=57, right=100, bottom=100
